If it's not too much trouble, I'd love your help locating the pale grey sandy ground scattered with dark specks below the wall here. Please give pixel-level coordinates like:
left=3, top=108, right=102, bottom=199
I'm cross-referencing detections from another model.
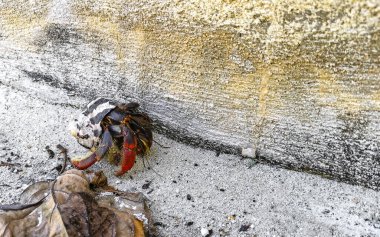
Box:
left=0, top=79, right=380, bottom=236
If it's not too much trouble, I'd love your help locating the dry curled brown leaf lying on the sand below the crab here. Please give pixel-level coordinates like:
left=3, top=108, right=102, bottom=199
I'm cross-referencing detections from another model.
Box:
left=0, top=170, right=153, bottom=237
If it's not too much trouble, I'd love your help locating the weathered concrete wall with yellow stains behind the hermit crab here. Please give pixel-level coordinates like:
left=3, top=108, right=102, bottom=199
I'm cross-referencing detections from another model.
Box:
left=0, top=0, right=380, bottom=188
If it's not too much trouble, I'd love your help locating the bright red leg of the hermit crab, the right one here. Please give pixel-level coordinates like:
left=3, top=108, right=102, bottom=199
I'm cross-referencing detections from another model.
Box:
left=115, top=126, right=137, bottom=176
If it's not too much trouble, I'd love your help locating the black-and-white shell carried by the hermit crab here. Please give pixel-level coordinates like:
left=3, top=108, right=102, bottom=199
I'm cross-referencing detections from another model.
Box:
left=69, top=98, right=117, bottom=148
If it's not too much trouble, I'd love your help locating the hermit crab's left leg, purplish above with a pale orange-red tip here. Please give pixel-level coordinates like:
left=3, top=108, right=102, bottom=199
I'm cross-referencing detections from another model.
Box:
left=71, top=129, right=112, bottom=170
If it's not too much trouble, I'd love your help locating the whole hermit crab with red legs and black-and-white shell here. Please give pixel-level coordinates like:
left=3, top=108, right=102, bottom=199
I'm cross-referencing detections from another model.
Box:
left=70, top=98, right=153, bottom=176
